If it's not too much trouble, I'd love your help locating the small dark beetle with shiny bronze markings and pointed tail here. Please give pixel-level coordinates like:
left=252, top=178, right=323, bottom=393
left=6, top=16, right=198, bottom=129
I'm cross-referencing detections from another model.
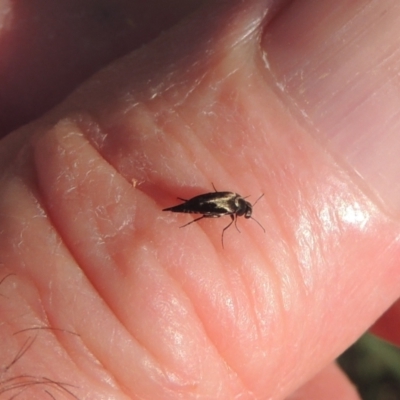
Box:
left=162, top=184, right=265, bottom=248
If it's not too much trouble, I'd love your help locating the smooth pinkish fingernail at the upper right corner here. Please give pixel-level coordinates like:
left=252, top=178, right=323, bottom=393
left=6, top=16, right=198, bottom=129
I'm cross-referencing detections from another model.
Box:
left=263, top=1, right=400, bottom=214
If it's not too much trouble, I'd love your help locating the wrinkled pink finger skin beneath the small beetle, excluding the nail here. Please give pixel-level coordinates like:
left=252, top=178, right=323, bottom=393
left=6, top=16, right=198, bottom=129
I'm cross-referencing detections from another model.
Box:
left=0, top=1, right=400, bottom=399
